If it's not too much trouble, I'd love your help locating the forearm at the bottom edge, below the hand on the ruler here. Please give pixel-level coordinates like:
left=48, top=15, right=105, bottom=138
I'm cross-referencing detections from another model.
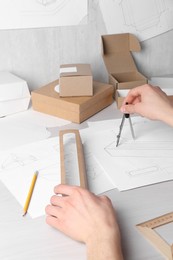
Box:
left=87, top=234, right=123, bottom=260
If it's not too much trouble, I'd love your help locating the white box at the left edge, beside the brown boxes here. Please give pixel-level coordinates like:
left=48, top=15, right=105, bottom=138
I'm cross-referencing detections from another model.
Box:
left=0, top=72, right=30, bottom=117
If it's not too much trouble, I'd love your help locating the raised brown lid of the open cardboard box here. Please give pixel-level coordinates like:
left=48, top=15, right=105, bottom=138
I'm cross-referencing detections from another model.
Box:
left=102, top=33, right=141, bottom=74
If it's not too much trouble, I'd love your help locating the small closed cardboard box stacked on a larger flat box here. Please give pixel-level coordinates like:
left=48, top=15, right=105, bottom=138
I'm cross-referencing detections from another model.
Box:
left=59, top=64, right=93, bottom=97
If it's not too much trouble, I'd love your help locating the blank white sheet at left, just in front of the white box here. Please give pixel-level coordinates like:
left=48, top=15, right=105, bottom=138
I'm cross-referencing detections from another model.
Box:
left=0, top=108, right=70, bottom=150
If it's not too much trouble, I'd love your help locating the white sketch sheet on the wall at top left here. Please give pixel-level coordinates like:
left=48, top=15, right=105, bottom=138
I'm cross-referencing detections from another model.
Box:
left=0, top=0, right=88, bottom=29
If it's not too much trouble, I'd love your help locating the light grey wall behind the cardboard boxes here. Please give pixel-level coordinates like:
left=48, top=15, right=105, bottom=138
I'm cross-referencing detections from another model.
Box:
left=0, top=0, right=173, bottom=90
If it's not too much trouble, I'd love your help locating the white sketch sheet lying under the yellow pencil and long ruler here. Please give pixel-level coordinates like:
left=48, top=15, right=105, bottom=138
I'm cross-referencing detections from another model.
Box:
left=0, top=134, right=114, bottom=218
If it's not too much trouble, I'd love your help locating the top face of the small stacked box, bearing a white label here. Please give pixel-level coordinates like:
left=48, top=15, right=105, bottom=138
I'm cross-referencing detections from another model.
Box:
left=60, top=64, right=92, bottom=77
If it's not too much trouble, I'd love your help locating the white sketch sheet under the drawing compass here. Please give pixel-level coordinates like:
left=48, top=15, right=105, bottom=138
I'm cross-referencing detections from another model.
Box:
left=85, top=117, right=173, bottom=190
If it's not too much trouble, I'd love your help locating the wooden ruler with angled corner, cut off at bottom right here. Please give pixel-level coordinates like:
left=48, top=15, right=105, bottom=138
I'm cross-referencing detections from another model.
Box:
left=137, top=212, right=173, bottom=260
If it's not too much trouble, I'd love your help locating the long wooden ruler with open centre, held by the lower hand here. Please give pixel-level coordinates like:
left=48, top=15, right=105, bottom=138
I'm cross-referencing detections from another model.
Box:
left=59, top=129, right=88, bottom=188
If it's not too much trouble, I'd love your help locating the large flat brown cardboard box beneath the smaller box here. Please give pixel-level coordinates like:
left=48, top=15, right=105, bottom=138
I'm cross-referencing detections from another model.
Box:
left=31, top=80, right=113, bottom=123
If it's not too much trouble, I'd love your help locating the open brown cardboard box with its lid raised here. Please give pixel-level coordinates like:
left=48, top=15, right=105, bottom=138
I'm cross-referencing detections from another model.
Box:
left=101, top=33, right=148, bottom=105
